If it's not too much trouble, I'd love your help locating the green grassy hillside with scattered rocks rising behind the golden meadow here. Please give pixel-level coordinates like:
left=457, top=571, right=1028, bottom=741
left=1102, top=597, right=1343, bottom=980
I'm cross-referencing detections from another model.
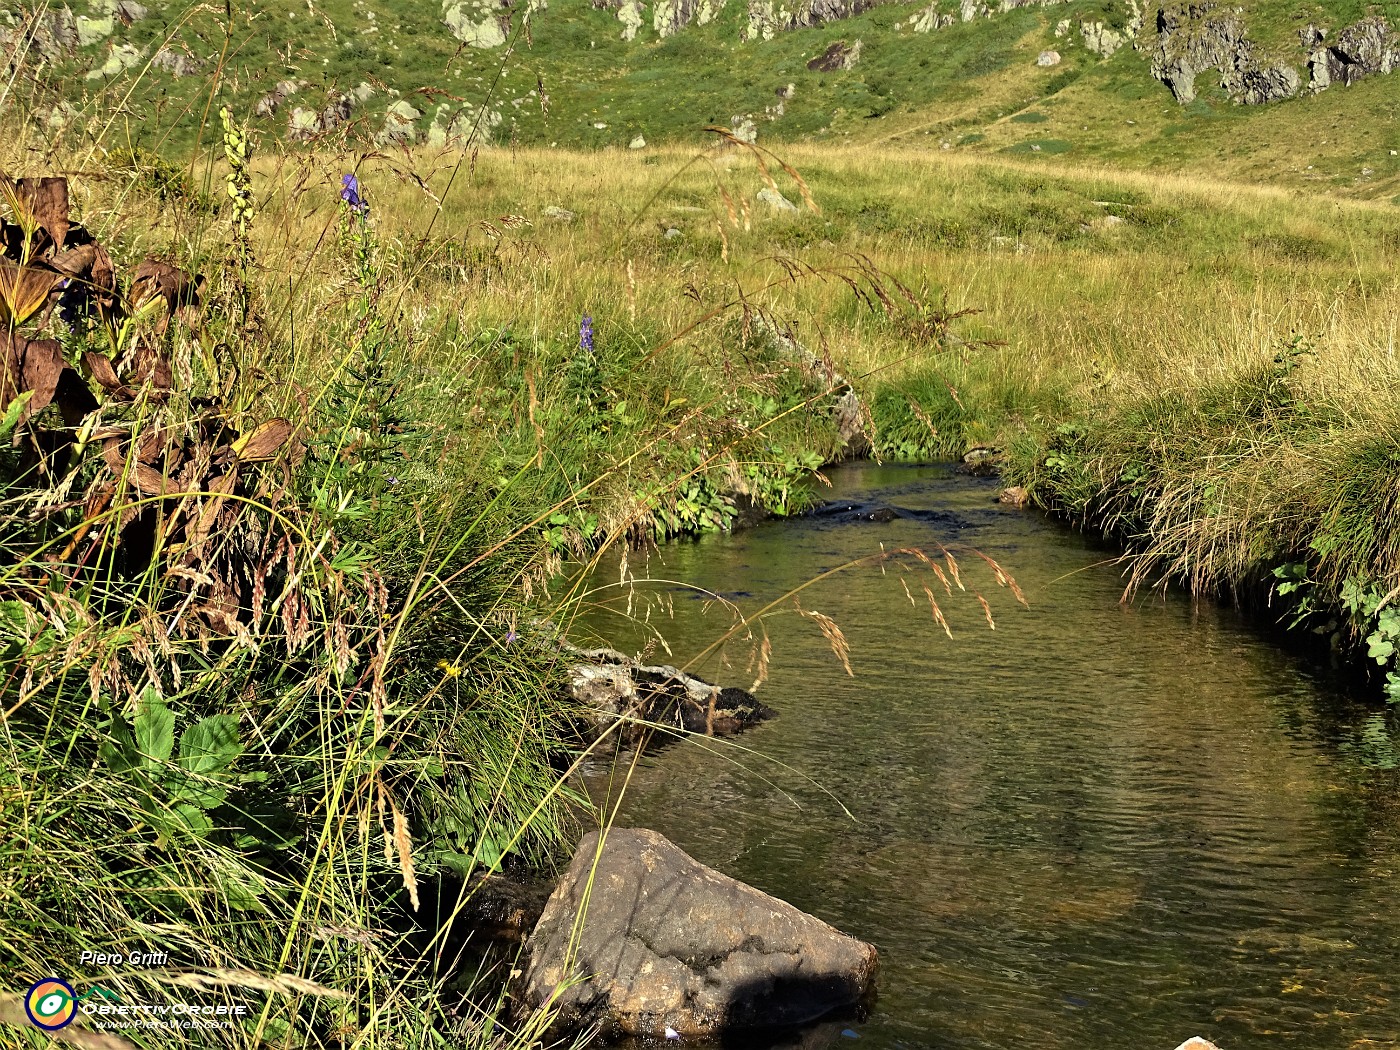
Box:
left=10, top=0, right=1400, bottom=199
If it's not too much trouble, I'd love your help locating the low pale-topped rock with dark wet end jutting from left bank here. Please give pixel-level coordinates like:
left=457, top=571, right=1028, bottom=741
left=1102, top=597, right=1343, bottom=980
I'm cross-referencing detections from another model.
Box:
left=564, top=644, right=774, bottom=743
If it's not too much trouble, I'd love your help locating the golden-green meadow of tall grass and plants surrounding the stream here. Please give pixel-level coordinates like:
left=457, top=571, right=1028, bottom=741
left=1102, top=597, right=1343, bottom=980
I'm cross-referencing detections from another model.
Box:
left=0, top=88, right=1400, bottom=1047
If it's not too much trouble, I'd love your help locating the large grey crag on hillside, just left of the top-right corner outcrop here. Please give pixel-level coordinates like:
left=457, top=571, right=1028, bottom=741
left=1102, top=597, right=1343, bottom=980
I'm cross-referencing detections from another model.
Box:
left=1152, top=0, right=1302, bottom=105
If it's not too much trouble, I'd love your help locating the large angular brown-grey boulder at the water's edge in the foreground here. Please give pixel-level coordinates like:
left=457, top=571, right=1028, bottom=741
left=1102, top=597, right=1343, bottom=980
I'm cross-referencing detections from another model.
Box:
left=524, top=827, right=876, bottom=1039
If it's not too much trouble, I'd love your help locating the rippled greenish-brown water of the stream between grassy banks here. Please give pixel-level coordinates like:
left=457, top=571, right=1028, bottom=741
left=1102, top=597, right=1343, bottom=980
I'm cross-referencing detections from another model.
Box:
left=574, top=465, right=1400, bottom=1050
